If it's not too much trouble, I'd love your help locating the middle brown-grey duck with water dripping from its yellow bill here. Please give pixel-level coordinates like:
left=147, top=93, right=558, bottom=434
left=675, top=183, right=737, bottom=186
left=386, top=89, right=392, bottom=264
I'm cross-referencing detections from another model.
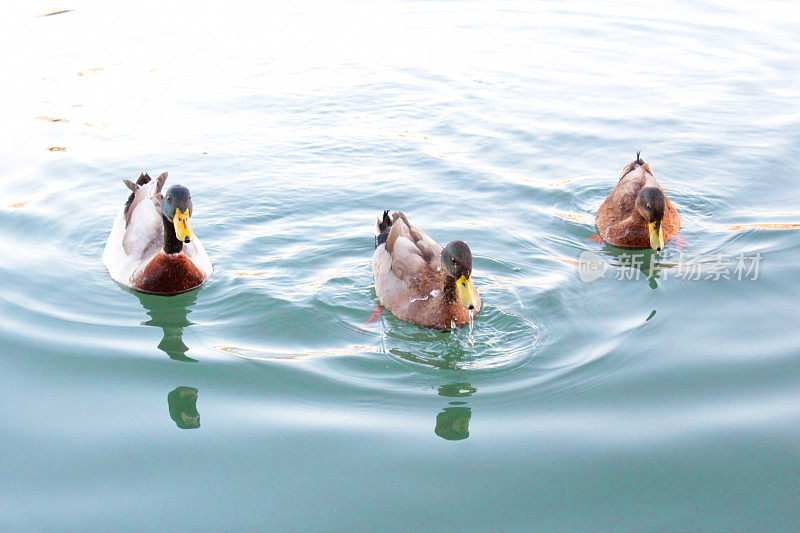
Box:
left=372, top=211, right=481, bottom=329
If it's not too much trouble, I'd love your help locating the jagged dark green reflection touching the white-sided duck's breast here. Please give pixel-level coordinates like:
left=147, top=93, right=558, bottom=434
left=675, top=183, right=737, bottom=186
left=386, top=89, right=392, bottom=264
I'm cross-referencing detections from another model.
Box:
left=132, top=291, right=197, bottom=363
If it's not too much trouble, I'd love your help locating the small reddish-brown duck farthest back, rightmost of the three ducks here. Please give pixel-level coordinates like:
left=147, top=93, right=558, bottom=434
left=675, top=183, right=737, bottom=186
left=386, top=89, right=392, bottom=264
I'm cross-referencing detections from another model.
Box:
left=596, top=152, right=681, bottom=252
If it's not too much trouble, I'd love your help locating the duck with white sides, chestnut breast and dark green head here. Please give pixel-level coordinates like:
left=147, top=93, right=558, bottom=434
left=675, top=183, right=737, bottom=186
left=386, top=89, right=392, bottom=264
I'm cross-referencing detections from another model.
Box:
left=103, top=172, right=212, bottom=296
